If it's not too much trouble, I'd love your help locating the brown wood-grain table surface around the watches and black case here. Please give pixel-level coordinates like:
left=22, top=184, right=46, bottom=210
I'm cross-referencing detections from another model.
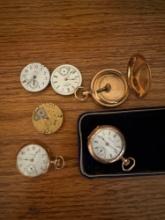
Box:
left=0, top=0, right=165, bottom=220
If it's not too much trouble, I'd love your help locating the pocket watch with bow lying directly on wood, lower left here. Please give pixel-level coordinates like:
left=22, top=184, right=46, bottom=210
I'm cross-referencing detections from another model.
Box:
left=16, top=144, right=65, bottom=177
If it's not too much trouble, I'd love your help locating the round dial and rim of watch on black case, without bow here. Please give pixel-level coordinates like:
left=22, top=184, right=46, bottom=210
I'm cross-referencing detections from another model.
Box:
left=89, top=126, right=125, bottom=163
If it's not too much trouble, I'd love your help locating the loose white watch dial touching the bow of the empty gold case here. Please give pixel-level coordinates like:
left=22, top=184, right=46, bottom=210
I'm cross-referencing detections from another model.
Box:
left=51, top=64, right=82, bottom=95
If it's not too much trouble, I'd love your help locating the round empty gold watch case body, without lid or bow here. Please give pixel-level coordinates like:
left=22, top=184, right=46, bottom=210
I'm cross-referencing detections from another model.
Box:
left=91, top=69, right=128, bottom=107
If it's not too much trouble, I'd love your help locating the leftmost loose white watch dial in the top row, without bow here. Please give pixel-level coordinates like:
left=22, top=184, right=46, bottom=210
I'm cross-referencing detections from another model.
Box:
left=20, top=63, right=50, bottom=92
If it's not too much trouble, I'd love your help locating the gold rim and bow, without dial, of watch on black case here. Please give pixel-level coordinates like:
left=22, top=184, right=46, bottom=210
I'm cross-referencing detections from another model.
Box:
left=88, top=125, right=136, bottom=172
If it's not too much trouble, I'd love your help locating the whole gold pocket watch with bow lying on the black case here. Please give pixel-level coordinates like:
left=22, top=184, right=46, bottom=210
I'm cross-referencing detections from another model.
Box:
left=88, top=125, right=135, bottom=171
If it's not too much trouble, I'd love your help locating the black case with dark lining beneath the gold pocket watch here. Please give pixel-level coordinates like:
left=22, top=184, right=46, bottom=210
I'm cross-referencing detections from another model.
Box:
left=78, top=107, right=165, bottom=177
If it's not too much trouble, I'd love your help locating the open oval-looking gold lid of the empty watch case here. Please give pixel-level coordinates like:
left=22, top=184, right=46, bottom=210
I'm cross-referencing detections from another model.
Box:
left=128, top=54, right=151, bottom=98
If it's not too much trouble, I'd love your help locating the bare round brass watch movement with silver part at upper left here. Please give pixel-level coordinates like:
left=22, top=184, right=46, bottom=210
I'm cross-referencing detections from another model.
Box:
left=32, top=103, right=63, bottom=134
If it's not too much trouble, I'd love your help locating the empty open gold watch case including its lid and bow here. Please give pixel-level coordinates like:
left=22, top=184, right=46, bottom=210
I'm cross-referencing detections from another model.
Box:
left=75, top=54, right=151, bottom=107
